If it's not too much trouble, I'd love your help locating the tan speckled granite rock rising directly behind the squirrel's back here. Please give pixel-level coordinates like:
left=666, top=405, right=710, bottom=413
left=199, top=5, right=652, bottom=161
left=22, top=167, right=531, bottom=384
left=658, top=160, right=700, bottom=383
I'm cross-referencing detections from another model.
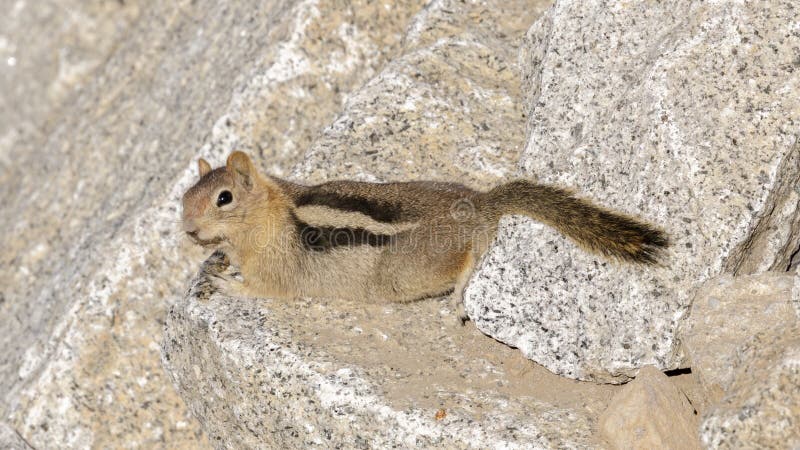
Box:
left=292, top=0, right=549, bottom=187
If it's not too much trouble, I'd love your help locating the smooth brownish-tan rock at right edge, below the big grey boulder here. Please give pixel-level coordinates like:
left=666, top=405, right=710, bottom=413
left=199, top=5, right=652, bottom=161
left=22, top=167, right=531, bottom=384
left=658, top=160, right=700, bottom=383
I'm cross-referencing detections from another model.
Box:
left=682, top=272, right=800, bottom=403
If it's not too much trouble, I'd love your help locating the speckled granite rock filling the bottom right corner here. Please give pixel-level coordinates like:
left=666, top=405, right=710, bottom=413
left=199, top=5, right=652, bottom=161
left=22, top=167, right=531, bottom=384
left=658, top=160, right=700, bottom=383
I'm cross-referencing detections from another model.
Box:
left=700, top=325, right=800, bottom=449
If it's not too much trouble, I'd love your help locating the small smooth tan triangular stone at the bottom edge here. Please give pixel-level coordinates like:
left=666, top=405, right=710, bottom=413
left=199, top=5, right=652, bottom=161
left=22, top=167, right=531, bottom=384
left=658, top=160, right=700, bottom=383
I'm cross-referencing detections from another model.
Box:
left=600, top=366, right=700, bottom=450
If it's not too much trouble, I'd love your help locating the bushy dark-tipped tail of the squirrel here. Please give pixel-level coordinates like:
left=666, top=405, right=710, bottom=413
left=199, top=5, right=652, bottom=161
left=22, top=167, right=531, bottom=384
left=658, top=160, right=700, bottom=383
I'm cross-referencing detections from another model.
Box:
left=483, top=180, right=669, bottom=264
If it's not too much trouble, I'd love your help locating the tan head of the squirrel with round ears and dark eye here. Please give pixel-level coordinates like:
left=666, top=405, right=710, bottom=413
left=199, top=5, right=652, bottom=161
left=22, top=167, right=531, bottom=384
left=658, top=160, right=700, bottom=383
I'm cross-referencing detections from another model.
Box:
left=182, top=151, right=277, bottom=247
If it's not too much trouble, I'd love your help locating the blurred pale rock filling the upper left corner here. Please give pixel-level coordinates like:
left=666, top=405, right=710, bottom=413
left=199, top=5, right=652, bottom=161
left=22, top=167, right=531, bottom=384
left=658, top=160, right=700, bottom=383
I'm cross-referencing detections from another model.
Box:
left=0, top=0, right=142, bottom=178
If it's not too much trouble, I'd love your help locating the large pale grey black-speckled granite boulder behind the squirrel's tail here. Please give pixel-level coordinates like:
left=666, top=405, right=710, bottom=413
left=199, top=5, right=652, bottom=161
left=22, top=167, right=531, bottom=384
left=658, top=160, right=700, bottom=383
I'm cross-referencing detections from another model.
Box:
left=466, top=1, right=800, bottom=382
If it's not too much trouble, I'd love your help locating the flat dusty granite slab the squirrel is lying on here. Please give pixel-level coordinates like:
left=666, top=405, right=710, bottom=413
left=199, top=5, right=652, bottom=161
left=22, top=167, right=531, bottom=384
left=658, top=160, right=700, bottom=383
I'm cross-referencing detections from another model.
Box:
left=163, top=251, right=603, bottom=449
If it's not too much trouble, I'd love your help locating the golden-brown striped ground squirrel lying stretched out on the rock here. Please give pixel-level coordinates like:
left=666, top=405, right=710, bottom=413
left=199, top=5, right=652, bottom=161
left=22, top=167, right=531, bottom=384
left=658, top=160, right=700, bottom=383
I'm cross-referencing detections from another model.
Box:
left=183, top=152, right=668, bottom=320
